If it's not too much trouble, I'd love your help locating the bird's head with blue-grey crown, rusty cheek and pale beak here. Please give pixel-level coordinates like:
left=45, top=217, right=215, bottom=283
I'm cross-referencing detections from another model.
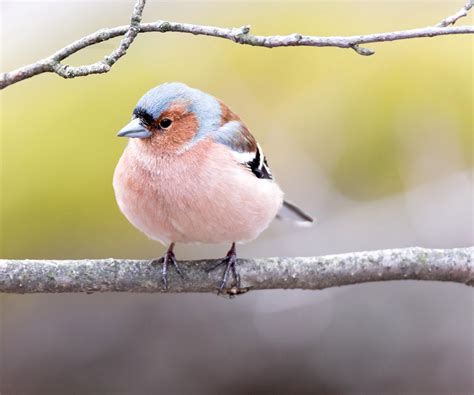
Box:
left=117, top=82, right=222, bottom=152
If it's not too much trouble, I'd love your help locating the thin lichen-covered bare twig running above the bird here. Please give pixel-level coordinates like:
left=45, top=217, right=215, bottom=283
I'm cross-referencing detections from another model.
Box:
left=0, top=0, right=474, bottom=89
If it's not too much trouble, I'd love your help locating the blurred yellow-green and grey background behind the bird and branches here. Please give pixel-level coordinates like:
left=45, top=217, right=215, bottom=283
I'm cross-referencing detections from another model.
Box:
left=0, top=0, right=474, bottom=394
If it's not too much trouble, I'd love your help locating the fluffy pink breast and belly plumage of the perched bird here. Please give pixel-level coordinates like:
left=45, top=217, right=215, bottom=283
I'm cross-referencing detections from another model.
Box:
left=114, top=139, right=283, bottom=244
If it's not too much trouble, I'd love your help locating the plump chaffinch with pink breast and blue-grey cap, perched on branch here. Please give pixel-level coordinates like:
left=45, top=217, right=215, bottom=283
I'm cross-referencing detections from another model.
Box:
left=113, top=82, right=314, bottom=292
